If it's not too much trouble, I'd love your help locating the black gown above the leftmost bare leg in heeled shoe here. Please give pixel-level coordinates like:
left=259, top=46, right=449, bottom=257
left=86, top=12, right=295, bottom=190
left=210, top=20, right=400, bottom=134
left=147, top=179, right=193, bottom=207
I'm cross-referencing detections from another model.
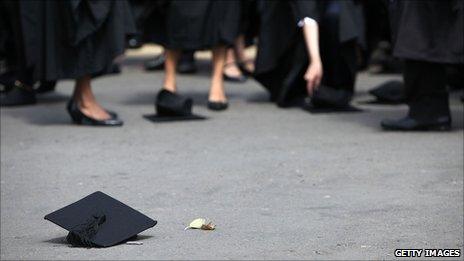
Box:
left=20, top=0, right=135, bottom=80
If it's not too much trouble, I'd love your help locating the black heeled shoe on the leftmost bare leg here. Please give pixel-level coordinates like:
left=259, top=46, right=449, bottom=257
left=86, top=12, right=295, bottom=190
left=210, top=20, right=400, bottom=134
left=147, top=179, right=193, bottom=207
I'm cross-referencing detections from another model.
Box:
left=66, top=99, right=124, bottom=127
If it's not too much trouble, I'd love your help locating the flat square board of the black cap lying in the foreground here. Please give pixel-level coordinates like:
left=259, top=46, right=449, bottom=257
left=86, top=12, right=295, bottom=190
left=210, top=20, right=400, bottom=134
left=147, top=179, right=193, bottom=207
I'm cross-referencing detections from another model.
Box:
left=45, top=191, right=157, bottom=247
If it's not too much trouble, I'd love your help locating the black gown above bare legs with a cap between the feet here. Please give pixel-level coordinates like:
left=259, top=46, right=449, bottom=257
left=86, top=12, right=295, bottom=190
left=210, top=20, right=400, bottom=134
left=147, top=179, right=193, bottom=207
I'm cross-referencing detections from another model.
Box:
left=144, top=0, right=240, bottom=50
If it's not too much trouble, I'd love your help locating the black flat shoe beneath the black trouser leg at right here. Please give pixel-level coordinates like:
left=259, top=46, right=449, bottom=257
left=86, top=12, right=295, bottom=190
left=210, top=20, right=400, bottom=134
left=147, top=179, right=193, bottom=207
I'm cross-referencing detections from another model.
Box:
left=380, top=116, right=451, bottom=131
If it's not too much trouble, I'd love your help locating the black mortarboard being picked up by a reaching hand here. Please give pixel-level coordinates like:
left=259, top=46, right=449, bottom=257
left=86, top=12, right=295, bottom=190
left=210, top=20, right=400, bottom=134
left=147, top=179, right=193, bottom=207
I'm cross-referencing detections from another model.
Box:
left=303, top=85, right=362, bottom=113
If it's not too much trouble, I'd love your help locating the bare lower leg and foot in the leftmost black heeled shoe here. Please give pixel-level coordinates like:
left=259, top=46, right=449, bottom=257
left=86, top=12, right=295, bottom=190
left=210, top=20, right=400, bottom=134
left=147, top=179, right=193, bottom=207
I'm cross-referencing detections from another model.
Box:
left=73, top=76, right=111, bottom=120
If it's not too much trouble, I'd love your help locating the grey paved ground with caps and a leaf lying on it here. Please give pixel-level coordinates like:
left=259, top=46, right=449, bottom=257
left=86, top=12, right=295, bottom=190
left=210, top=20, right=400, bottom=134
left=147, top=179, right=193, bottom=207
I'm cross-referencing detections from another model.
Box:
left=1, top=57, right=463, bottom=259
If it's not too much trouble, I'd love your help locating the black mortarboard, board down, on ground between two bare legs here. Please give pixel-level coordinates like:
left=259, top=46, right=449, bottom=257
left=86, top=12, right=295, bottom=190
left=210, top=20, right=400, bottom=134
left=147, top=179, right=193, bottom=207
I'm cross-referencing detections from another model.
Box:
left=143, top=89, right=206, bottom=122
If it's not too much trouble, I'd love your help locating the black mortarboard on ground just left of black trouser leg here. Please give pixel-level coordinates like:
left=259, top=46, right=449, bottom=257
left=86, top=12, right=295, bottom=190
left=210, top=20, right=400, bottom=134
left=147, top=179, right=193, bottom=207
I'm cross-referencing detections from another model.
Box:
left=368, top=80, right=406, bottom=104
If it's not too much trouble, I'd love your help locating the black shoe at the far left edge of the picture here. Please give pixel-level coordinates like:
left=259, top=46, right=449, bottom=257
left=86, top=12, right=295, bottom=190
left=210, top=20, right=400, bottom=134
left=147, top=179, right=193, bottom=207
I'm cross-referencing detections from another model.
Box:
left=0, top=81, right=36, bottom=106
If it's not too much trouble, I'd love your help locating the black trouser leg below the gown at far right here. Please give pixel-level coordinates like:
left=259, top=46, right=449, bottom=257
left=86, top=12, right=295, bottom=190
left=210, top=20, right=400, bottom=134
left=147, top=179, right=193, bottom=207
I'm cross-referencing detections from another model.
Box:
left=403, top=60, right=450, bottom=121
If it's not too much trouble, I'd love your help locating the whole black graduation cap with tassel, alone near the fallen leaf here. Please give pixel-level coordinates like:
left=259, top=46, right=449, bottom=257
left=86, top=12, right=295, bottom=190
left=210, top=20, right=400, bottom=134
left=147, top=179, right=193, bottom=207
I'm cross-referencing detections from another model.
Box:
left=45, top=191, right=157, bottom=247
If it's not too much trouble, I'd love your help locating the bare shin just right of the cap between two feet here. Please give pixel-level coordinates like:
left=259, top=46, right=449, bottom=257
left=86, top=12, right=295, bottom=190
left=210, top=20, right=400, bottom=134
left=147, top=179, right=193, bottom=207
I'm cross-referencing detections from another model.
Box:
left=209, top=46, right=227, bottom=102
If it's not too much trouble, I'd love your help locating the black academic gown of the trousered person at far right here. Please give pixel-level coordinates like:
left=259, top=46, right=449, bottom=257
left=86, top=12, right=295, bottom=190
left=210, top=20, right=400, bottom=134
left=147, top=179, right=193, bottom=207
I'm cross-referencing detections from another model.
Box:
left=390, top=0, right=464, bottom=64
